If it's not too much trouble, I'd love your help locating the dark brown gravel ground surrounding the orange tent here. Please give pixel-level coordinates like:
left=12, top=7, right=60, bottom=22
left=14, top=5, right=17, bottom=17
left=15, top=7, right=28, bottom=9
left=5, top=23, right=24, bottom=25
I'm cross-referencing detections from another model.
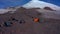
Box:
left=0, top=8, right=60, bottom=34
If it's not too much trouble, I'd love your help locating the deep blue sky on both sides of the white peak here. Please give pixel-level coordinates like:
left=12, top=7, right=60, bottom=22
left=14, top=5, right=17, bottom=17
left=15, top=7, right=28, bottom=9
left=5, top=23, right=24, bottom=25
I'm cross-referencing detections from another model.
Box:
left=0, top=0, right=60, bottom=8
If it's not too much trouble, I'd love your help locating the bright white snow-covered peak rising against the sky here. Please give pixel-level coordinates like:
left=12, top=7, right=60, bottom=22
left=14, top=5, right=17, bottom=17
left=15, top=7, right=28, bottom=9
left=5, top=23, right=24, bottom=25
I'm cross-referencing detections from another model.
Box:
left=23, top=0, right=60, bottom=10
